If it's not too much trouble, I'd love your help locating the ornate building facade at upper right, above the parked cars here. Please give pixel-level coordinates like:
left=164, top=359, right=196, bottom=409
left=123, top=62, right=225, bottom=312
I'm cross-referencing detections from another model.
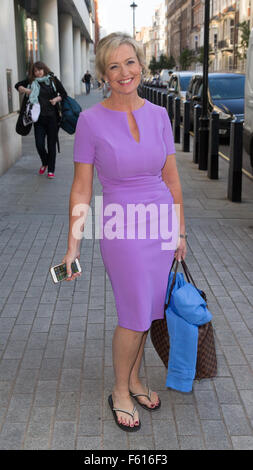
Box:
left=166, top=0, right=253, bottom=72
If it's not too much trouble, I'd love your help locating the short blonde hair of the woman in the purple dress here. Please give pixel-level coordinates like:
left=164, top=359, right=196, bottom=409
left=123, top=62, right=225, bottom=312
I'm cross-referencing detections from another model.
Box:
left=96, top=32, right=147, bottom=80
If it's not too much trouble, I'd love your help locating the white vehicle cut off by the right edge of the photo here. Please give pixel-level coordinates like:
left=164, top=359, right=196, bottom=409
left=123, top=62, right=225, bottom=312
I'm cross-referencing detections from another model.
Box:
left=243, top=29, right=253, bottom=169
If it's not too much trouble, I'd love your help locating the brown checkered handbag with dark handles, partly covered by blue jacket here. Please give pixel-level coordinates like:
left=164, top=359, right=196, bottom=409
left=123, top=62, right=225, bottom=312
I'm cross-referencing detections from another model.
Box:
left=150, top=259, right=217, bottom=380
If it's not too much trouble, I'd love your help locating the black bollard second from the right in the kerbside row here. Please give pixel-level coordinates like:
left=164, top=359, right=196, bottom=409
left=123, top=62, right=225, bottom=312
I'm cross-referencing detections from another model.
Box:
left=207, top=111, right=219, bottom=180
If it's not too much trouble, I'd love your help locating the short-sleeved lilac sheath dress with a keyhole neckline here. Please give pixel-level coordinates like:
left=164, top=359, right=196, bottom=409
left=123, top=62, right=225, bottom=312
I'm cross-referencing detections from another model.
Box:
left=74, top=100, right=178, bottom=331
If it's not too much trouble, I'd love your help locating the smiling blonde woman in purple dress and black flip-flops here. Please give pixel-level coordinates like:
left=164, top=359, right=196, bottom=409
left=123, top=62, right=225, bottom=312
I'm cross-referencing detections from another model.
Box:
left=63, top=33, right=186, bottom=431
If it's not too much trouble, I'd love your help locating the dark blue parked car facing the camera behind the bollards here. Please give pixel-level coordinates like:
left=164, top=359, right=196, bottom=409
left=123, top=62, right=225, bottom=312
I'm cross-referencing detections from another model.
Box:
left=186, top=72, right=245, bottom=138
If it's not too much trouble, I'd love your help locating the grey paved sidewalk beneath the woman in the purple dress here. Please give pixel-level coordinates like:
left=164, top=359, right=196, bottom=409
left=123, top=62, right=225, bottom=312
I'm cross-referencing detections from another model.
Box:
left=0, top=90, right=253, bottom=450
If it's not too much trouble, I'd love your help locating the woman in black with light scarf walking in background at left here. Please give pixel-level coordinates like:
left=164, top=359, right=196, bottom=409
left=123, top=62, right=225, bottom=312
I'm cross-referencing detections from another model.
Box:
left=15, top=62, right=67, bottom=179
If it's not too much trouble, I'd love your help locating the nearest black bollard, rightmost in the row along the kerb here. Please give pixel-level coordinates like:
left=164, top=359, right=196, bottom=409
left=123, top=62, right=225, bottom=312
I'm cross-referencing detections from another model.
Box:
left=228, top=120, right=243, bottom=202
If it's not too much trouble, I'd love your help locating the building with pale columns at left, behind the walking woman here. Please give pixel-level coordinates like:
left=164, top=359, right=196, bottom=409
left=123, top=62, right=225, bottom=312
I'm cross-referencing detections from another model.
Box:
left=0, top=0, right=95, bottom=174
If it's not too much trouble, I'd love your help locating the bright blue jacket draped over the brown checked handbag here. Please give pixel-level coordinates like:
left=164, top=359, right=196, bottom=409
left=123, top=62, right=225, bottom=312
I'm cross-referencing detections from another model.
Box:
left=166, top=272, right=212, bottom=392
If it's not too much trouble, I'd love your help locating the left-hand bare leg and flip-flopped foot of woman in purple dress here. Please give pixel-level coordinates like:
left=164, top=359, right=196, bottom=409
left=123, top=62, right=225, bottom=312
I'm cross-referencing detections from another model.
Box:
left=112, top=326, right=143, bottom=426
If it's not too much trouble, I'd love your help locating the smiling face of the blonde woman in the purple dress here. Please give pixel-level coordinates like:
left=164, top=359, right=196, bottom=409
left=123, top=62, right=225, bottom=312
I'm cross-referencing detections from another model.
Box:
left=105, top=44, right=142, bottom=94
